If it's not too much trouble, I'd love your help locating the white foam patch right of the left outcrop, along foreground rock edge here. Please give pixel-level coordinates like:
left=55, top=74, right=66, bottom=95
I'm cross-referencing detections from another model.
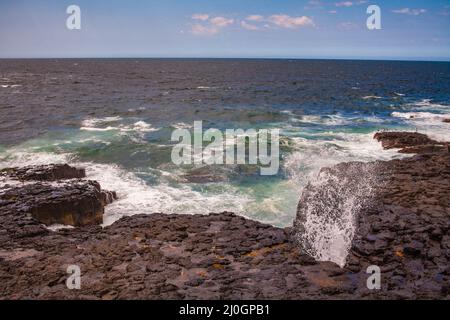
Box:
left=84, top=164, right=249, bottom=225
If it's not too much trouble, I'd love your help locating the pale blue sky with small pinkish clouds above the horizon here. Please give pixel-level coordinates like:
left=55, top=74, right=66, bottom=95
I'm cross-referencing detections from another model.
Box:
left=0, top=0, right=450, bottom=61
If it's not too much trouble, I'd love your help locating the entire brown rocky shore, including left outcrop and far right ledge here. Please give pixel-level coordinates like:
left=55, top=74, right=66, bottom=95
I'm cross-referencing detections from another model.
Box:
left=0, top=132, right=450, bottom=299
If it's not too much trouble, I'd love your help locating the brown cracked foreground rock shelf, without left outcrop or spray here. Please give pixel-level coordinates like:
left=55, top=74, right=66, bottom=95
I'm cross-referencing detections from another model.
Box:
left=0, top=133, right=450, bottom=300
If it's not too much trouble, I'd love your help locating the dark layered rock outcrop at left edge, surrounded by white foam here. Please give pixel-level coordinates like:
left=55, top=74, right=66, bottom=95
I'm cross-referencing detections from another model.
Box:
left=0, top=165, right=116, bottom=226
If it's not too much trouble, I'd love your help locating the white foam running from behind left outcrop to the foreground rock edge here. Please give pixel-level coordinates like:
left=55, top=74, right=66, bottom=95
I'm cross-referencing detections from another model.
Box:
left=0, top=151, right=251, bottom=225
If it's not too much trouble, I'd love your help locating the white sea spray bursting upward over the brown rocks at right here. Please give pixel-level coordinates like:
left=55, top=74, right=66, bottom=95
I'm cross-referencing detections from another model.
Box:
left=294, top=162, right=379, bottom=267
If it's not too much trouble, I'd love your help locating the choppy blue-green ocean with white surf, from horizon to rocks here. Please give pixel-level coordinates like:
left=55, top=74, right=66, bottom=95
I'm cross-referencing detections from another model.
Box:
left=0, top=59, right=450, bottom=227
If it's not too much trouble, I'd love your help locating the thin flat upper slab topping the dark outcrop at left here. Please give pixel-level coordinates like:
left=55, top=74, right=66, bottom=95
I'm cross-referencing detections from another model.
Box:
left=0, top=164, right=86, bottom=181
